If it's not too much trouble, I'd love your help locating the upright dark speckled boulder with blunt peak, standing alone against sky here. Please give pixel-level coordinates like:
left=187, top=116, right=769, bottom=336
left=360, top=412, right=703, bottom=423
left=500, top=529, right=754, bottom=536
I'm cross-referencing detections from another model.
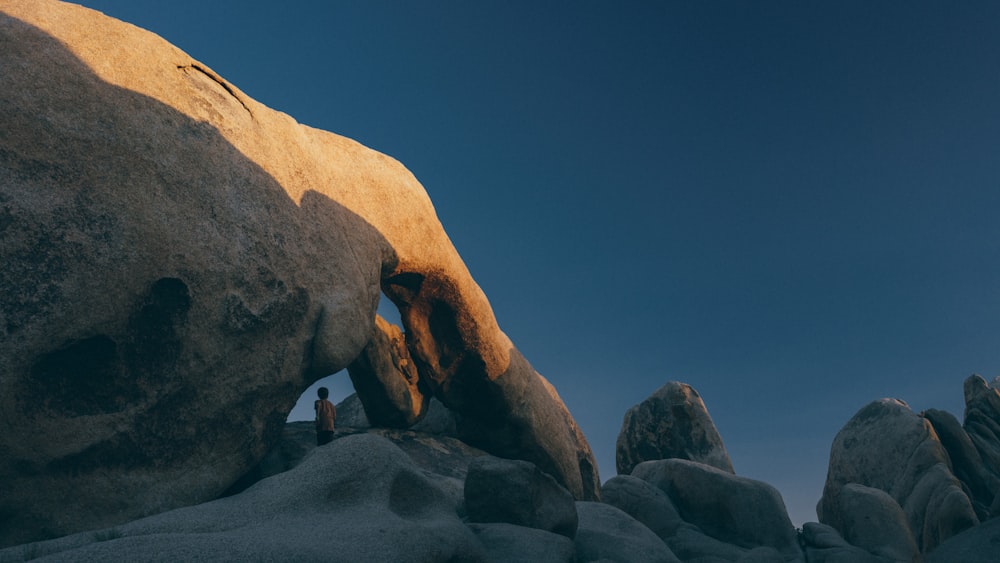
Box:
left=615, top=381, right=733, bottom=475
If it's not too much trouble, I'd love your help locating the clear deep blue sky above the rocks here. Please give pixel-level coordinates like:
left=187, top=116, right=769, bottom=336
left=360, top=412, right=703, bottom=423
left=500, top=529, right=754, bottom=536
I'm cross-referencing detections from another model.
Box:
left=72, top=0, right=1000, bottom=524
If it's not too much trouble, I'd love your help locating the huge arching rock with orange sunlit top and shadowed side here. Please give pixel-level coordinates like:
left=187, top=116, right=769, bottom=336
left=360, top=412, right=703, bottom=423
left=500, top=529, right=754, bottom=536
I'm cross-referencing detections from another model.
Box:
left=0, top=0, right=596, bottom=545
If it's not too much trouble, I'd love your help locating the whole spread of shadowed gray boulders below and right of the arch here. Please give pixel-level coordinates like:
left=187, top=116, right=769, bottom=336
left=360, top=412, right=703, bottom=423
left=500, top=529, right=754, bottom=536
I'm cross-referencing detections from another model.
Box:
left=0, top=376, right=1000, bottom=563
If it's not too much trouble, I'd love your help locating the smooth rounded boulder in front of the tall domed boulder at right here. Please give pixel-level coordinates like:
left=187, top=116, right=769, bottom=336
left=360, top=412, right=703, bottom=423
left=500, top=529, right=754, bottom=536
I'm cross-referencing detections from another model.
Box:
left=839, top=483, right=920, bottom=561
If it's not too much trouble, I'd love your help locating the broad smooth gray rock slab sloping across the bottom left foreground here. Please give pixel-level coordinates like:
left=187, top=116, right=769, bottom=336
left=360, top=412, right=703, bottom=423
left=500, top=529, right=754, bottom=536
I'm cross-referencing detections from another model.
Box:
left=0, top=434, right=487, bottom=562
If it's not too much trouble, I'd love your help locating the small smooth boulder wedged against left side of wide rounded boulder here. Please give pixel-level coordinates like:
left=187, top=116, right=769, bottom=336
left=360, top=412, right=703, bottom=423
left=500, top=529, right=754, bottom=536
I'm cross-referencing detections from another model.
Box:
left=601, top=475, right=684, bottom=540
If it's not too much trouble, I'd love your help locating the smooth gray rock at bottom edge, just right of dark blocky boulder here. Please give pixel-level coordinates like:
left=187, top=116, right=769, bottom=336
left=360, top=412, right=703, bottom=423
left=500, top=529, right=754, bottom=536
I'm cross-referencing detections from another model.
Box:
left=576, top=502, right=680, bottom=563
